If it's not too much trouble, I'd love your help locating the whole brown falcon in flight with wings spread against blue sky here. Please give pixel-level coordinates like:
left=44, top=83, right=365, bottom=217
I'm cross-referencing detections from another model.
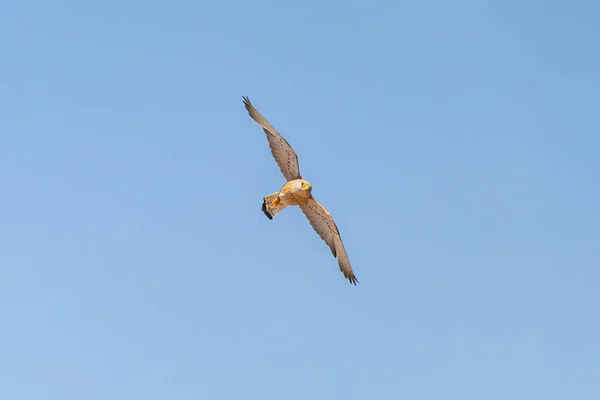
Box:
left=243, top=96, right=358, bottom=285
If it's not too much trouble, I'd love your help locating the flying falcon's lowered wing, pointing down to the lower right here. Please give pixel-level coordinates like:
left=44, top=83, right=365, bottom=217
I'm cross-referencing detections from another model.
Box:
left=300, top=197, right=358, bottom=285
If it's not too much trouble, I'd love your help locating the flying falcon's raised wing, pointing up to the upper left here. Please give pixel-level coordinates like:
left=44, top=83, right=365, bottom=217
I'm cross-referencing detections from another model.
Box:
left=242, top=96, right=302, bottom=181
